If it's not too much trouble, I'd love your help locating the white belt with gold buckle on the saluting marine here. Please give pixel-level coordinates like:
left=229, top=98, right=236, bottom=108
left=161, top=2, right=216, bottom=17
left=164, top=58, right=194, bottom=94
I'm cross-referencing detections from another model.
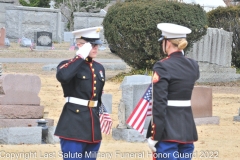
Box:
left=65, top=97, right=98, bottom=107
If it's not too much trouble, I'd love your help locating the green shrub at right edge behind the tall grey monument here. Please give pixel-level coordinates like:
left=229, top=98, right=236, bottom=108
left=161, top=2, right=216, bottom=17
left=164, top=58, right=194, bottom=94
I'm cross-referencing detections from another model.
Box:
left=207, top=6, right=240, bottom=68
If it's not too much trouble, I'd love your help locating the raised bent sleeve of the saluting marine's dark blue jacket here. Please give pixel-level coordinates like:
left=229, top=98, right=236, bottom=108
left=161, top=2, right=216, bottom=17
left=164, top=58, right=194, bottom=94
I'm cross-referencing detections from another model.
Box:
left=56, top=56, right=84, bottom=83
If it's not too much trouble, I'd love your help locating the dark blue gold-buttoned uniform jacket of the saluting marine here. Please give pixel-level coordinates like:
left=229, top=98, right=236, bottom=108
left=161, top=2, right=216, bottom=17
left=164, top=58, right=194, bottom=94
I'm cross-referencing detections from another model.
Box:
left=55, top=56, right=105, bottom=143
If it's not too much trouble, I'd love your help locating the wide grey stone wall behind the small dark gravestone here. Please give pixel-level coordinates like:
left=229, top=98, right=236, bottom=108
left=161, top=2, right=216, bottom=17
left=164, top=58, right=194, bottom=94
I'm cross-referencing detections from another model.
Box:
left=5, top=6, right=63, bottom=42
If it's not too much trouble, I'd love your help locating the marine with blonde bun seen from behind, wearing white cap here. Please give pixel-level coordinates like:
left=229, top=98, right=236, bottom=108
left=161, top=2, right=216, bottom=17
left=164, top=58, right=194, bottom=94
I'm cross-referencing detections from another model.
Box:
left=147, top=23, right=199, bottom=160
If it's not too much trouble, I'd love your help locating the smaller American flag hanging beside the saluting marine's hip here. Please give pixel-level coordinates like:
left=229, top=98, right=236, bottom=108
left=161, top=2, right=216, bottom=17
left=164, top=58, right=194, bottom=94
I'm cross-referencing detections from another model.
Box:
left=99, top=104, right=113, bottom=134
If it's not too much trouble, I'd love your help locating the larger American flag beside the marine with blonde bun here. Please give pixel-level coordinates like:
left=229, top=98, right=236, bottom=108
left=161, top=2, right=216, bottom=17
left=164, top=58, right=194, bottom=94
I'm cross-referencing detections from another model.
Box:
left=127, top=84, right=152, bottom=134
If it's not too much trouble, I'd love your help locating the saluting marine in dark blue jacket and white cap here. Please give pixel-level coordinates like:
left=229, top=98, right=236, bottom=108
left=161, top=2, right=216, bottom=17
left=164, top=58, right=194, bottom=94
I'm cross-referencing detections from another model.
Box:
left=55, top=27, right=105, bottom=160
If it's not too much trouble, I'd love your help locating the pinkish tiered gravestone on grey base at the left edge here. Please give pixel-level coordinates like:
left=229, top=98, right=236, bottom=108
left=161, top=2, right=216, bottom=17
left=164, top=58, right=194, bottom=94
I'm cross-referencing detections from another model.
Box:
left=0, top=74, right=54, bottom=144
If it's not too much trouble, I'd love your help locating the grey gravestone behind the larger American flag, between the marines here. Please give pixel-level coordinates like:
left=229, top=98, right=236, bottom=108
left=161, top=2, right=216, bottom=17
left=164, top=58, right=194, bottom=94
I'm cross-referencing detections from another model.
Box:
left=112, top=75, right=152, bottom=142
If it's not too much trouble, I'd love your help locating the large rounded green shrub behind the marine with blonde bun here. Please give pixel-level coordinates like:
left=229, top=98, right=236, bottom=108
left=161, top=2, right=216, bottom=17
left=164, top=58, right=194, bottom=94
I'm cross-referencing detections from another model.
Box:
left=103, top=0, right=207, bottom=69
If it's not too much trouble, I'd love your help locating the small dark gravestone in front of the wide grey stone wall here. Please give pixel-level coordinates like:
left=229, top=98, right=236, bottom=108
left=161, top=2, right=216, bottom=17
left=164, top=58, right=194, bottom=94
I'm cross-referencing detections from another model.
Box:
left=34, top=31, right=52, bottom=50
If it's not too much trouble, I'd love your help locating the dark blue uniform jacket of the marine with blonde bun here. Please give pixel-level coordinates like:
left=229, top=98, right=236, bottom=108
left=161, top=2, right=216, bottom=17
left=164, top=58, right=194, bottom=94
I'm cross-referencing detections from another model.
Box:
left=147, top=52, right=199, bottom=143
